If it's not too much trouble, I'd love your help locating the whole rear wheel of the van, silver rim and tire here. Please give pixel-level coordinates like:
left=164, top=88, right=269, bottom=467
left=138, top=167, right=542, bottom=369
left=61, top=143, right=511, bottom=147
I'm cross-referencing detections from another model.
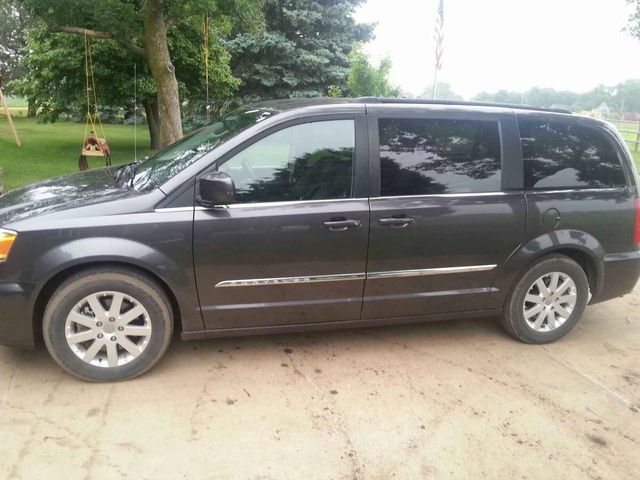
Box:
left=502, top=255, right=589, bottom=343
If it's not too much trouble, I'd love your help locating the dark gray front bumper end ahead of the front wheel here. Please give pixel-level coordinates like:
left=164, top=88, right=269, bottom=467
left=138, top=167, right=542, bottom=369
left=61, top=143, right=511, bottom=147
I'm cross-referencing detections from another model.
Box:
left=0, top=282, right=35, bottom=348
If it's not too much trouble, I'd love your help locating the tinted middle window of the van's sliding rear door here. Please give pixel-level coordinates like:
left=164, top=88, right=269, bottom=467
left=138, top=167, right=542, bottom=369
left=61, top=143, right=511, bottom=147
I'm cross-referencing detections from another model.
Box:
left=379, top=119, right=500, bottom=196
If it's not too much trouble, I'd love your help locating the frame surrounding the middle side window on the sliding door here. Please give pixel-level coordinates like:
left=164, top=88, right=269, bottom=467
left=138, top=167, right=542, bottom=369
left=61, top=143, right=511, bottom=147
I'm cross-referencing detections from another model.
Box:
left=368, top=105, right=524, bottom=198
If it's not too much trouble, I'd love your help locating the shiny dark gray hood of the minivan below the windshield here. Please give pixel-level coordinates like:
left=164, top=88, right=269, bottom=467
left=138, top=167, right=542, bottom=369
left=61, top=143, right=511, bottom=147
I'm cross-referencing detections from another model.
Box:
left=0, top=168, right=131, bottom=226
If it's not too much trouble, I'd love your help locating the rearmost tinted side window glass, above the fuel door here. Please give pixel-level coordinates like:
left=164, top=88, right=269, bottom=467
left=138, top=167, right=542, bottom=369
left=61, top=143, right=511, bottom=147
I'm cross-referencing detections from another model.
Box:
left=518, top=119, right=626, bottom=190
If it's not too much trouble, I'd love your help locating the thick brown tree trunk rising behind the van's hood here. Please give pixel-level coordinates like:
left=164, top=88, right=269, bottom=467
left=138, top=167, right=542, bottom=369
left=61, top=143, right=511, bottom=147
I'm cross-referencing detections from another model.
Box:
left=142, top=0, right=182, bottom=146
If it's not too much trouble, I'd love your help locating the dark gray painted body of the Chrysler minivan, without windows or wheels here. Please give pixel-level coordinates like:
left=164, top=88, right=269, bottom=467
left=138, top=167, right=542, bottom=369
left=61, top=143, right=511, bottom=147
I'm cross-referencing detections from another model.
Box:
left=0, top=102, right=640, bottom=346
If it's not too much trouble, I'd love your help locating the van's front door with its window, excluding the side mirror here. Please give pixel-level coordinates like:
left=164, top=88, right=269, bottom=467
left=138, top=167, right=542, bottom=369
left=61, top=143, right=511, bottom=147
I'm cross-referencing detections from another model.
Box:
left=194, top=116, right=369, bottom=329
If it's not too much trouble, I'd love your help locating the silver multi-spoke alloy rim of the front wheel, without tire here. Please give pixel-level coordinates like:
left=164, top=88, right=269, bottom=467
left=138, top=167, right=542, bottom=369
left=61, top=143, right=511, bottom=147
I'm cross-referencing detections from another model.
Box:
left=65, top=292, right=151, bottom=368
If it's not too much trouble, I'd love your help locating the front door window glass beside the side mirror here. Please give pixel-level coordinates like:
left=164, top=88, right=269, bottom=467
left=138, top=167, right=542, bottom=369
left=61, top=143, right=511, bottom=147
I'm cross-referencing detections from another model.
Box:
left=218, top=120, right=355, bottom=203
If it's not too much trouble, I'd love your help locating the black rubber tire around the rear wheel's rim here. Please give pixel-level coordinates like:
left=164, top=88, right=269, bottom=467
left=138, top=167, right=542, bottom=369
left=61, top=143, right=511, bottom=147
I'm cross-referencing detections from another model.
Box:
left=502, top=255, right=589, bottom=344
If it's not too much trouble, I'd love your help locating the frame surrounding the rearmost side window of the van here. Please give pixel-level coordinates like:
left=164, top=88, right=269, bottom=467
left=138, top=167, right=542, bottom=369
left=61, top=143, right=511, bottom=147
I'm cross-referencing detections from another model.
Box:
left=516, top=112, right=635, bottom=195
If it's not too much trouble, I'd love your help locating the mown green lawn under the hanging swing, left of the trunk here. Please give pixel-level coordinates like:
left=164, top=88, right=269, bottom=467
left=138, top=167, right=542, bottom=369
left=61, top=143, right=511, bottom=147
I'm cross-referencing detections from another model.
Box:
left=0, top=116, right=149, bottom=191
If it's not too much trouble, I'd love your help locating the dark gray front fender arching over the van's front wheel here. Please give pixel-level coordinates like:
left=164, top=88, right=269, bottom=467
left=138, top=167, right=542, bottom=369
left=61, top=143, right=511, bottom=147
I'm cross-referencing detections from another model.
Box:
left=30, top=237, right=203, bottom=330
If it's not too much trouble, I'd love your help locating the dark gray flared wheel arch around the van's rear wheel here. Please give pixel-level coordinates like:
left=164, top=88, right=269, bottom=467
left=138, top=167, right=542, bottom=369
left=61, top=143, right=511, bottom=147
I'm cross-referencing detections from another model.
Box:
left=486, top=230, right=605, bottom=308
